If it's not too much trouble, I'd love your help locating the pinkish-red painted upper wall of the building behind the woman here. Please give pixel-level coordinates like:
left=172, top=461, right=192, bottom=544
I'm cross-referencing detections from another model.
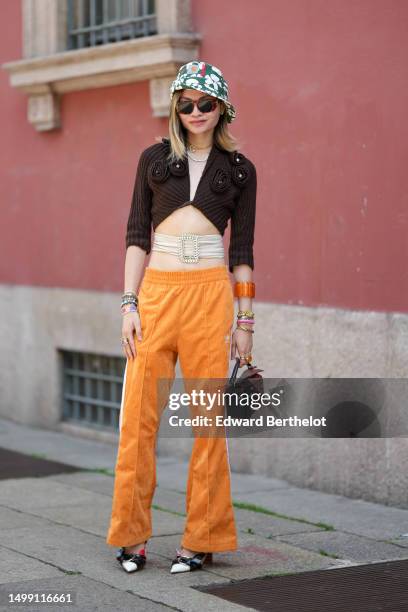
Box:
left=0, top=0, right=408, bottom=311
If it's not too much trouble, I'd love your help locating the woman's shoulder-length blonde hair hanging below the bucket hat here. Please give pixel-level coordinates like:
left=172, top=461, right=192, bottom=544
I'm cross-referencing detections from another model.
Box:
left=156, top=89, right=240, bottom=163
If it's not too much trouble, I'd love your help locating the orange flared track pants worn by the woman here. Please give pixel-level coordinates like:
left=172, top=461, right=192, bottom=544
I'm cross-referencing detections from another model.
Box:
left=106, top=266, right=237, bottom=552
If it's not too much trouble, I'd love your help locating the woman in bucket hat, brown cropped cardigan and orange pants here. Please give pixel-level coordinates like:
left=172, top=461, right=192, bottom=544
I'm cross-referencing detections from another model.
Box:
left=106, top=61, right=257, bottom=573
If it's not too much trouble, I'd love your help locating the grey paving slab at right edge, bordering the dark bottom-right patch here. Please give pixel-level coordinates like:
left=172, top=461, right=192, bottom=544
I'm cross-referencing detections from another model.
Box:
left=277, top=531, right=408, bottom=563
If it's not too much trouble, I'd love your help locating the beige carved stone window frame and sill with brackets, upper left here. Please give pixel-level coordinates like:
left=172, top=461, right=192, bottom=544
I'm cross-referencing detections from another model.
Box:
left=2, top=0, right=201, bottom=131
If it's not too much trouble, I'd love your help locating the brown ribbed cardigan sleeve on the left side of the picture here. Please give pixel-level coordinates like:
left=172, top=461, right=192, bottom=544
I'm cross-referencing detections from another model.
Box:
left=126, top=150, right=152, bottom=255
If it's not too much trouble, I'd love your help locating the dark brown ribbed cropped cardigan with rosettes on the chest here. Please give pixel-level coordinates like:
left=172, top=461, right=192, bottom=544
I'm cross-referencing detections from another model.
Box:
left=126, top=138, right=257, bottom=272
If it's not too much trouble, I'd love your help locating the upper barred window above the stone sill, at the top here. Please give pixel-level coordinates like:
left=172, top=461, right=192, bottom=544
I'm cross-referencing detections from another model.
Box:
left=67, top=0, right=157, bottom=50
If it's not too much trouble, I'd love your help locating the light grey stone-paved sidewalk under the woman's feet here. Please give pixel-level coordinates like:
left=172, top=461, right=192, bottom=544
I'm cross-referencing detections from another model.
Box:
left=0, top=420, right=408, bottom=612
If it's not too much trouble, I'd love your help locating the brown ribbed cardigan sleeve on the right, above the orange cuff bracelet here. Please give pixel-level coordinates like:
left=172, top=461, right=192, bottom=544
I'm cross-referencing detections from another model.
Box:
left=228, top=159, right=257, bottom=272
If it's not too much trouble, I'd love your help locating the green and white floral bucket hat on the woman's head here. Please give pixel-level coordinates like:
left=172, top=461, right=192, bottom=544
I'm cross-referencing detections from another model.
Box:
left=170, top=61, right=236, bottom=123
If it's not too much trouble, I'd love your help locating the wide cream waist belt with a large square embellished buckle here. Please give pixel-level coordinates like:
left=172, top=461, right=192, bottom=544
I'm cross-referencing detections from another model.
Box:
left=152, top=232, right=224, bottom=263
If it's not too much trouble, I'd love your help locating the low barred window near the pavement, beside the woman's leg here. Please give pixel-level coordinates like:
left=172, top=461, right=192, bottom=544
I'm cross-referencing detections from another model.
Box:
left=61, top=351, right=126, bottom=431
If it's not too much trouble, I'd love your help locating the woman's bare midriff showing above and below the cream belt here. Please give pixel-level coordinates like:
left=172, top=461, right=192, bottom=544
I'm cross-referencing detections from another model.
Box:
left=147, top=204, right=226, bottom=270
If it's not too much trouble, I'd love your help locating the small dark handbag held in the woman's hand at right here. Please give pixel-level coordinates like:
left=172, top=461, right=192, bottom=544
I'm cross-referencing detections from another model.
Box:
left=224, top=357, right=264, bottom=419
